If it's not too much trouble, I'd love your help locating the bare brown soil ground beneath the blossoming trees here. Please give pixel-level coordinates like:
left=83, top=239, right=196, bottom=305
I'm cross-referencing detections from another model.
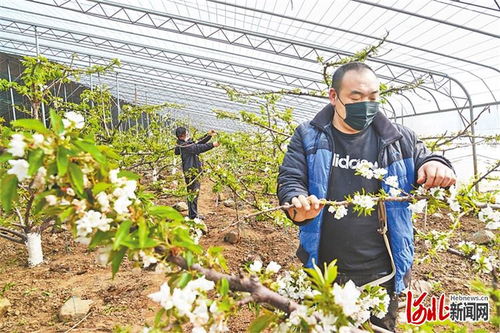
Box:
left=0, top=184, right=494, bottom=332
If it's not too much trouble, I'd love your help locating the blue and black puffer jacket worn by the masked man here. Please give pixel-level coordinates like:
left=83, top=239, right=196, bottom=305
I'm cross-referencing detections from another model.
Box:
left=277, top=104, right=451, bottom=293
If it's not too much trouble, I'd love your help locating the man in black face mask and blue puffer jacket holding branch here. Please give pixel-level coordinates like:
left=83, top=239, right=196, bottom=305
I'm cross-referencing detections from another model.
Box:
left=278, top=62, right=456, bottom=330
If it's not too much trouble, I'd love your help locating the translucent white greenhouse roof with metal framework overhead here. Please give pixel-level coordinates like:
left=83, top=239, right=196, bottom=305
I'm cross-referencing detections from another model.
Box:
left=0, top=0, right=500, bottom=130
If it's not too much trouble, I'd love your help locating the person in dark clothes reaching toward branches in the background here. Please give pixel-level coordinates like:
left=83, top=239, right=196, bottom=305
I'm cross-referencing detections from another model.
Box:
left=175, top=127, right=219, bottom=219
